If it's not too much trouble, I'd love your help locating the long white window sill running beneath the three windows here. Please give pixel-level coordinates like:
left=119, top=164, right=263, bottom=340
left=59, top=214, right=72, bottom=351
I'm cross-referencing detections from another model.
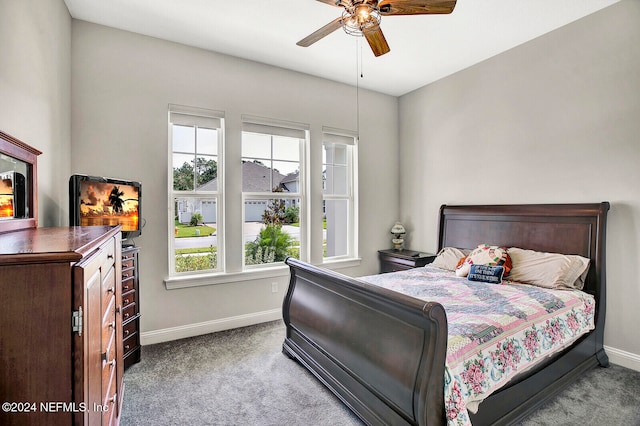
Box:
left=164, top=258, right=361, bottom=290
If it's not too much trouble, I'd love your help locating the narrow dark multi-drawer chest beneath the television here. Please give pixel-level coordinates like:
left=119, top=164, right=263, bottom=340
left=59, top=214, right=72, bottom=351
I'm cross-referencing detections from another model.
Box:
left=122, top=246, right=140, bottom=369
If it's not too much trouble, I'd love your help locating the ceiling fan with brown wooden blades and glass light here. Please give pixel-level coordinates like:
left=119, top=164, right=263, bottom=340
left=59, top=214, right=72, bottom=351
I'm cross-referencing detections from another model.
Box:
left=296, top=0, right=456, bottom=56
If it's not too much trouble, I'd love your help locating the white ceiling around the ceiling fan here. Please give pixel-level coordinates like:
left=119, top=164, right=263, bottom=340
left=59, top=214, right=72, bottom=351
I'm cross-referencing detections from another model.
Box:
left=65, top=0, right=619, bottom=96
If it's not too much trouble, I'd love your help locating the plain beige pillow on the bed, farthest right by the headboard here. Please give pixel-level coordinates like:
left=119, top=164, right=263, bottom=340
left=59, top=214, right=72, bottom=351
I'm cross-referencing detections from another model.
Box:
left=508, top=247, right=589, bottom=290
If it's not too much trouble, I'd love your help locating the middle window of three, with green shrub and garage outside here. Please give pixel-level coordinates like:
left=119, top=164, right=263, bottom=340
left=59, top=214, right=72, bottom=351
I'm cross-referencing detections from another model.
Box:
left=241, top=116, right=308, bottom=267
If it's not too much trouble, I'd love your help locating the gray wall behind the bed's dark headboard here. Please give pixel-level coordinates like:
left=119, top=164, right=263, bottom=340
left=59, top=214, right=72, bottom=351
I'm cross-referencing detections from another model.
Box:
left=399, top=0, right=640, bottom=369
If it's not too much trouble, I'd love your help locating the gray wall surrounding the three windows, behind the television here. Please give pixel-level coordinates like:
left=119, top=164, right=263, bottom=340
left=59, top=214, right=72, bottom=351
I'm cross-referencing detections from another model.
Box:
left=71, top=20, right=400, bottom=343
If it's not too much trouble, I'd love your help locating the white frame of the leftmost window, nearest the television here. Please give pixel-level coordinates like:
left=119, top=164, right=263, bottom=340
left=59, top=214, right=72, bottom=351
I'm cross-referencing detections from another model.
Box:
left=167, top=104, right=225, bottom=277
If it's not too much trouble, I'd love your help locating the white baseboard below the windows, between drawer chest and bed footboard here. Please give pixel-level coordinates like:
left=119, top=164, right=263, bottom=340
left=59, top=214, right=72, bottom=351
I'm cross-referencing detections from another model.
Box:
left=140, top=309, right=282, bottom=346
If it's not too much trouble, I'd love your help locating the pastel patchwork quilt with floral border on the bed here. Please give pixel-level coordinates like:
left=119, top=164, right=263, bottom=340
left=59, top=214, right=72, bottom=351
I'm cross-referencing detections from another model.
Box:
left=361, top=265, right=595, bottom=425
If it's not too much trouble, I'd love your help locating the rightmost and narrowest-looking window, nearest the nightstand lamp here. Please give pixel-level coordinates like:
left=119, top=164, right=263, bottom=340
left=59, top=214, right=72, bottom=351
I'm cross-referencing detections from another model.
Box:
left=322, top=128, right=357, bottom=260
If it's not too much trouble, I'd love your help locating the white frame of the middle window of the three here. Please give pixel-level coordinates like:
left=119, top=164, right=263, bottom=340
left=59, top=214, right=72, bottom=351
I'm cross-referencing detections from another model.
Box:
left=241, top=115, right=310, bottom=271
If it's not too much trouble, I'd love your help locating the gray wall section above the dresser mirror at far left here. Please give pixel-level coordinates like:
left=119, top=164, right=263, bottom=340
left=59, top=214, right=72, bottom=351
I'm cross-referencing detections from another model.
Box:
left=0, top=0, right=71, bottom=226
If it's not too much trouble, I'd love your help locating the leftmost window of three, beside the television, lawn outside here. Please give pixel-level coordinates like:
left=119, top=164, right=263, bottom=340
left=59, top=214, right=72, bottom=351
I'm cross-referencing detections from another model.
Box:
left=169, top=105, right=224, bottom=274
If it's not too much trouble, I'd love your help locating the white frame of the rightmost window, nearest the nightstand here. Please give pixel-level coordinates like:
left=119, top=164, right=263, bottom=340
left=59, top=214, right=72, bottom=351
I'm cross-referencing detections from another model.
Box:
left=318, top=126, right=358, bottom=263
